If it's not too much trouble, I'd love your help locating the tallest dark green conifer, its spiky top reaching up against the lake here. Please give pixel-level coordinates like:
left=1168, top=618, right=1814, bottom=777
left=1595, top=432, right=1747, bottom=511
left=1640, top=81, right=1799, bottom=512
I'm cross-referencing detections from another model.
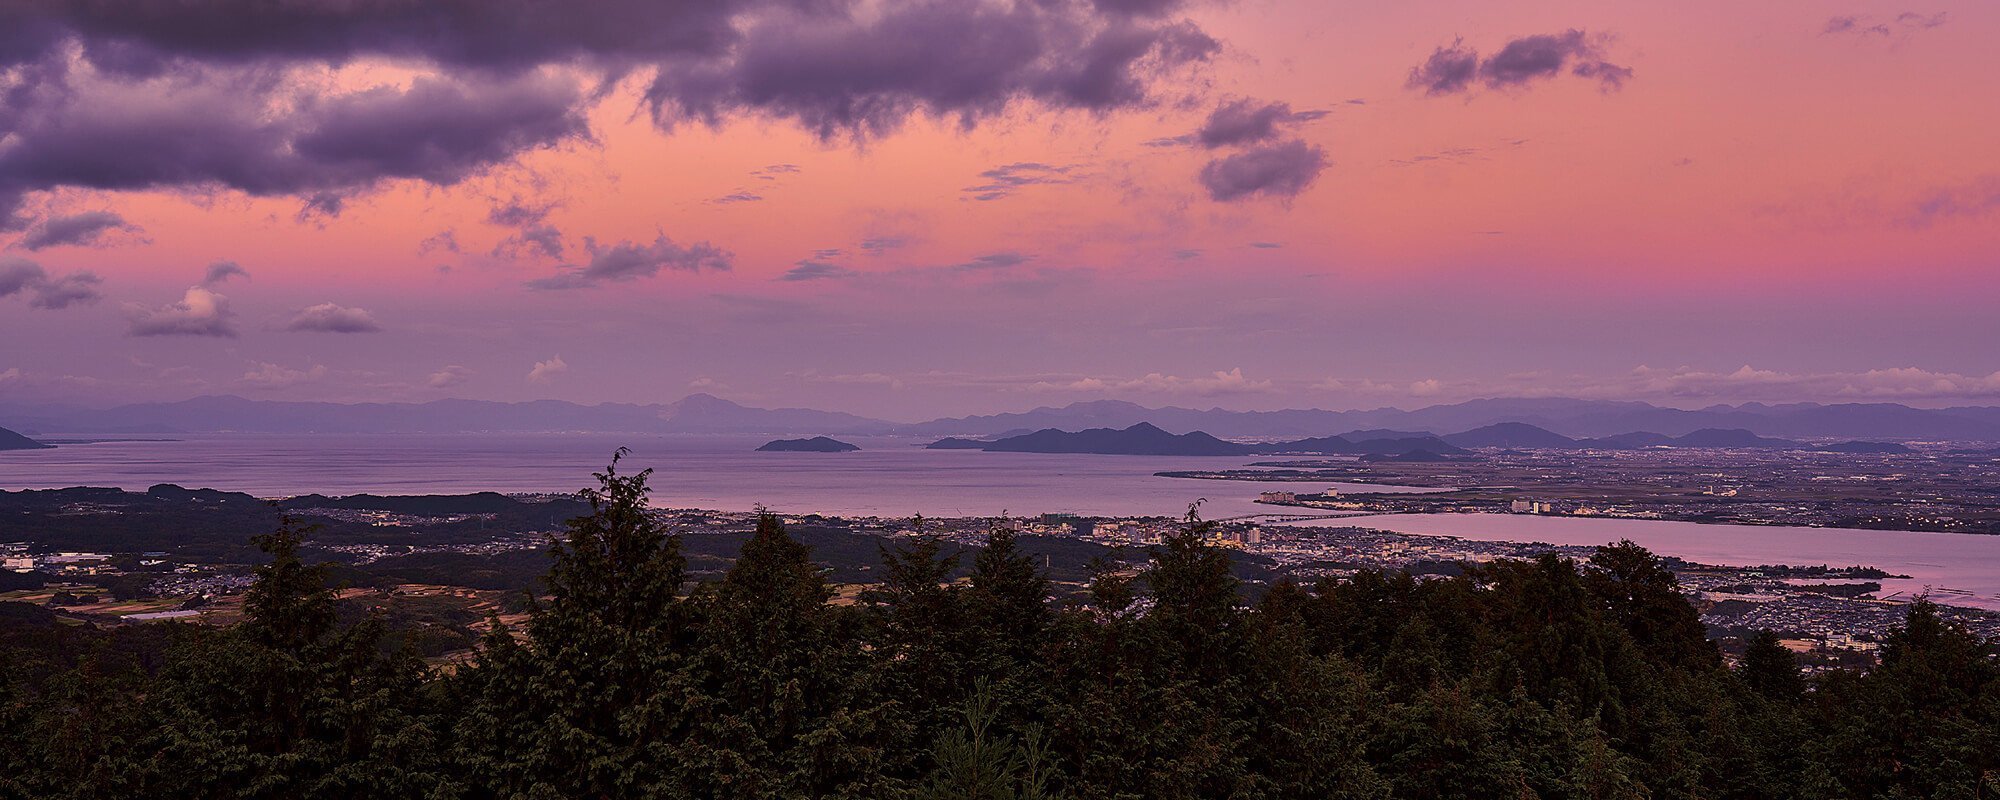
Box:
left=456, top=448, right=692, bottom=798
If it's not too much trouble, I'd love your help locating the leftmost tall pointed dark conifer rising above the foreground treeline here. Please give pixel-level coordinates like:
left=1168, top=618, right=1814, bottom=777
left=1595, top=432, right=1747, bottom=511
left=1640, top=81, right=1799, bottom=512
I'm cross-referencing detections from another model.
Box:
left=129, top=518, right=458, bottom=798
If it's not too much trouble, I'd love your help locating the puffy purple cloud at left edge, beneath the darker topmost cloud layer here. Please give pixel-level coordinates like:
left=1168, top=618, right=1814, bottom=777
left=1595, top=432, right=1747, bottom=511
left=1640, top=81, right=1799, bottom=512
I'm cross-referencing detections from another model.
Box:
left=0, top=72, right=586, bottom=228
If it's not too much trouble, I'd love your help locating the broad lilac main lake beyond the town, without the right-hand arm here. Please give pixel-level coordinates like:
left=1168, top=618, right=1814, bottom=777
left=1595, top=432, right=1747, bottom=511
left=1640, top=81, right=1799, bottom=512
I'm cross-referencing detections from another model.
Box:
left=0, top=434, right=1418, bottom=518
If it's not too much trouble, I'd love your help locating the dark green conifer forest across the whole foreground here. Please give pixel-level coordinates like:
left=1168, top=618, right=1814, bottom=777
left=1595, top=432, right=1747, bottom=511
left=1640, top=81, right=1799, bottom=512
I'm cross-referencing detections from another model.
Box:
left=0, top=458, right=2000, bottom=800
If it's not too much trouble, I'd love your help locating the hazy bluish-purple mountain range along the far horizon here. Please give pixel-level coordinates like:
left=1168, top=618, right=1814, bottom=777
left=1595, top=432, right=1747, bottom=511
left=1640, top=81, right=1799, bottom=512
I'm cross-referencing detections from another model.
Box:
left=0, top=394, right=2000, bottom=440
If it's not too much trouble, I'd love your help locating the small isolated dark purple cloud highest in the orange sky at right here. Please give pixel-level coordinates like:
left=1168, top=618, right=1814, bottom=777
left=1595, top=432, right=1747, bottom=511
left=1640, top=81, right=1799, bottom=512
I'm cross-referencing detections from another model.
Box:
left=1408, top=28, right=1632, bottom=96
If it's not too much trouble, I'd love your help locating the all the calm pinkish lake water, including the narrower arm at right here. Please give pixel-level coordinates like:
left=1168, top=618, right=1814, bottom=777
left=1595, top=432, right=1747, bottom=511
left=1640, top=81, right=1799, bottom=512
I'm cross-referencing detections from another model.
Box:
left=0, top=434, right=2000, bottom=608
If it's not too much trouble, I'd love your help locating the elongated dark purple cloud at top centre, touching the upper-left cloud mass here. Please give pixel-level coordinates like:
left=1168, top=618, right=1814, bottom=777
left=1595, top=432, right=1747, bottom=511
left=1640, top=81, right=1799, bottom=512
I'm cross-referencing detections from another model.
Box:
left=646, top=2, right=1220, bottom=138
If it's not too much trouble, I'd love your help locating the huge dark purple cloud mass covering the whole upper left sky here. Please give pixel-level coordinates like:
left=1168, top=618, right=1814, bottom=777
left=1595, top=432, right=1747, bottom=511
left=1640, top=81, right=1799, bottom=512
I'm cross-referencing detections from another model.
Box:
left=0, top=0, right=1220, bottom=230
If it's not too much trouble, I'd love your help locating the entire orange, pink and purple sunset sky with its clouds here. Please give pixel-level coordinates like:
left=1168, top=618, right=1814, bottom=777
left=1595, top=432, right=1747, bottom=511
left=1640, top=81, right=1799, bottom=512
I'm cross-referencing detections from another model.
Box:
left=0, top=0, right=2000, bottom=420
